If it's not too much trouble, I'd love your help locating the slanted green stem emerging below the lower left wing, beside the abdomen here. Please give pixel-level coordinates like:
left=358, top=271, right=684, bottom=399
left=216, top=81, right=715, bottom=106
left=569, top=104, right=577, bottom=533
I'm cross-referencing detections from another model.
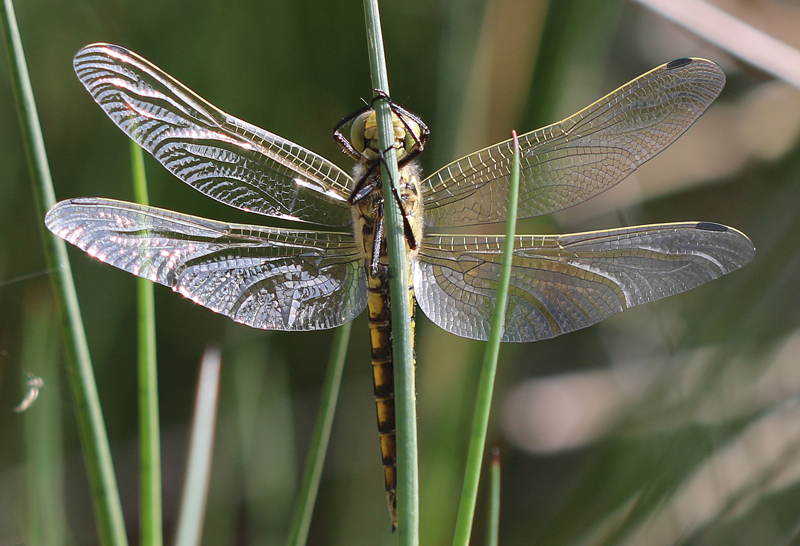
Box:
left=288, top=322, right=353, bottom=546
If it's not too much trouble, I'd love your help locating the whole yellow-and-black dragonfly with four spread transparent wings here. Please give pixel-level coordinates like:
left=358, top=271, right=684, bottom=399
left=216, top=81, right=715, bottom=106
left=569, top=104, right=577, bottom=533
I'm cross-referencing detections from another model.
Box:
left=45, top=44, right=755, bottom=524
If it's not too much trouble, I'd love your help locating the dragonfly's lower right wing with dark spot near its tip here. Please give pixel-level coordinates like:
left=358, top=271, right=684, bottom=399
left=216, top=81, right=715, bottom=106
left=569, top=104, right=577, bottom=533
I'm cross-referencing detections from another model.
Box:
left=413, top=222, right=755, bottom=342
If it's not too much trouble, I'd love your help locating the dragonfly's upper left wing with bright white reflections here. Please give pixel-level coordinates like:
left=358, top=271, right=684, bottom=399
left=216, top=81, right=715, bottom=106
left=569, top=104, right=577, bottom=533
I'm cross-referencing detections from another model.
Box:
left=73, top=44, right=351, bottom=226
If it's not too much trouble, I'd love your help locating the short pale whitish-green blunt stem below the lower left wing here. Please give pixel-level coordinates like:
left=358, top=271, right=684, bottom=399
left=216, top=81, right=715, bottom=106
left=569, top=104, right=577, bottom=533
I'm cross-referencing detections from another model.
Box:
left=175, top=346, right=222, bottom=546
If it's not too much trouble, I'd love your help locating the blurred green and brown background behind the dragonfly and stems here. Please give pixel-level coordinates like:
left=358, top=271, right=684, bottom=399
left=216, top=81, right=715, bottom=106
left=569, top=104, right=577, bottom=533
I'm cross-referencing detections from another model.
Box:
left=0, top=0, right=800, bottom=546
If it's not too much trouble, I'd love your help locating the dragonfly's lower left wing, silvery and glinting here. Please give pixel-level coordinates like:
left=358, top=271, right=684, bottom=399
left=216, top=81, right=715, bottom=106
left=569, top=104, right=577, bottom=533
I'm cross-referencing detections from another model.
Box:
left=45, top=198, right=367, bottom=330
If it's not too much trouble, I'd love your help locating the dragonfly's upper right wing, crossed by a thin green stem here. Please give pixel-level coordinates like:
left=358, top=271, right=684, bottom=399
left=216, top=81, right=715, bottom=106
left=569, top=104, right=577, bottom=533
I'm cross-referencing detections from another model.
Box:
left=422, top=59, right=725, bottom=227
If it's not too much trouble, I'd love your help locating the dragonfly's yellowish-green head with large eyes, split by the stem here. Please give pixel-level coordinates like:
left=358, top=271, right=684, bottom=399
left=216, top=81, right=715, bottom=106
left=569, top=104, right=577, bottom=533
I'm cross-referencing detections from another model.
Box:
left=350, top=109, right=427, bottom=162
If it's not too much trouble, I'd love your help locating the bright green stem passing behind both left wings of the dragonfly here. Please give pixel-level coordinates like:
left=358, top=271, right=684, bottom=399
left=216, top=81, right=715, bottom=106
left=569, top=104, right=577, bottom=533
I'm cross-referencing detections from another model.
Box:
left=130, top=141, right=164, bottom=546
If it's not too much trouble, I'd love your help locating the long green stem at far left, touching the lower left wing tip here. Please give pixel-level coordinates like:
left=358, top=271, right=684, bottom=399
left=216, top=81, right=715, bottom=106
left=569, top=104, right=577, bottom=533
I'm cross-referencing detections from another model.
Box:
left=0, top=0, right=128, bottom=546
